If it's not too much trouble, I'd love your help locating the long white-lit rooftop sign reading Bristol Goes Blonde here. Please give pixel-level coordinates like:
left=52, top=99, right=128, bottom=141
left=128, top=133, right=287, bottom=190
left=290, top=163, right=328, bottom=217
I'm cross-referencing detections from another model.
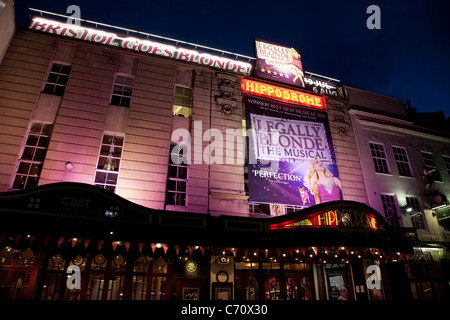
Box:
left=29, top=17, right=252, bottom=76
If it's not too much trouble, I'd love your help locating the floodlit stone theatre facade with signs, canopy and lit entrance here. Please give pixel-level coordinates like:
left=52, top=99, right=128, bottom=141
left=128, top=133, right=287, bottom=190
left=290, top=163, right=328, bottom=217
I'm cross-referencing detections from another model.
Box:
left=0, top=9, right=450, bottom=301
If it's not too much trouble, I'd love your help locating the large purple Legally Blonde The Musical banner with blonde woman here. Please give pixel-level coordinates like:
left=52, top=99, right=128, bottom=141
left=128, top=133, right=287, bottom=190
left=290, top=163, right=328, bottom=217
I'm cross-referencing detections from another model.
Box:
left=244, top=95, right=342, bottom=207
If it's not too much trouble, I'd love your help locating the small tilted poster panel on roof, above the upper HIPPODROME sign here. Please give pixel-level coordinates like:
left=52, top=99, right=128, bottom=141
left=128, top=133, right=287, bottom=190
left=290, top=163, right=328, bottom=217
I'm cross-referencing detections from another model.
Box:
left=255, top=39, right=305, bottom=88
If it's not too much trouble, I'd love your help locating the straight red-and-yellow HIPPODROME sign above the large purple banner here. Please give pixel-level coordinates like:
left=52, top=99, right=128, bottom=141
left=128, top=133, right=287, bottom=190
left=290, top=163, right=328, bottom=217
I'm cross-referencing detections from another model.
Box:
left=241, top=79, right=326, bottom=110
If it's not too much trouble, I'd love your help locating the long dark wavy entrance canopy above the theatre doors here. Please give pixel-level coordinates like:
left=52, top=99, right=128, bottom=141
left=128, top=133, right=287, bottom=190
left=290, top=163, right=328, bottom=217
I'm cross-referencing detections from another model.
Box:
left=0, top=182, right=417, bottom=251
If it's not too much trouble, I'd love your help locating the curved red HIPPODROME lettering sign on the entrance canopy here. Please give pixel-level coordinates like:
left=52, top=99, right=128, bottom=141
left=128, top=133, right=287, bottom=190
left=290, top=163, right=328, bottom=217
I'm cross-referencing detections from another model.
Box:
left=270, top=209, right=379, bottom=231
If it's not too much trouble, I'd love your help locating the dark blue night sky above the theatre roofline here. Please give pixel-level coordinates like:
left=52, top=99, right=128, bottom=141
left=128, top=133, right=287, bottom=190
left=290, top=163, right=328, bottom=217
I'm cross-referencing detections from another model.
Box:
left=16, top=0, right=450, bottom=117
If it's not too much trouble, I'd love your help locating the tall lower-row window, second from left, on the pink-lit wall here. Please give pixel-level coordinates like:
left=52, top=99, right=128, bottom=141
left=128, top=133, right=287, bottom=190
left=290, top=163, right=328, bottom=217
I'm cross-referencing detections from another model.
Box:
left=93, top=132, right=125, bottom=193
